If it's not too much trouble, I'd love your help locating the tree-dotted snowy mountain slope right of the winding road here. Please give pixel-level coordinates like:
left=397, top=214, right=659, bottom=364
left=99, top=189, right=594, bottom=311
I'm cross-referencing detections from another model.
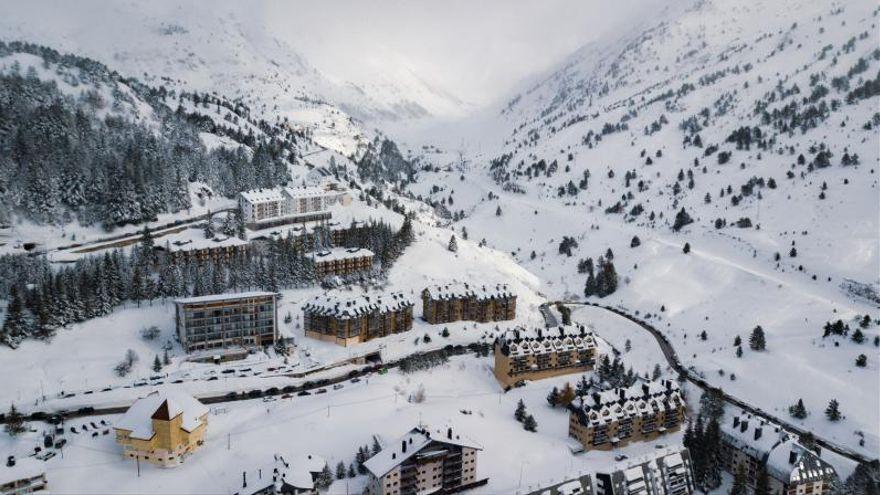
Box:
left=411, top=0, right=880, bottom=458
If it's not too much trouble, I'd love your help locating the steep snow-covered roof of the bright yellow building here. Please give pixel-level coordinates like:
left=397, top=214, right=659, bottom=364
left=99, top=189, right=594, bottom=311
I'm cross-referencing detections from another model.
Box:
left=115, top=388, right=208, bottom=440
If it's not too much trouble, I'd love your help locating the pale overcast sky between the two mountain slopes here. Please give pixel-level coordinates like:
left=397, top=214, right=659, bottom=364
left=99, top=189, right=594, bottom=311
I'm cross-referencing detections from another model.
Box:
left=257, top=0, right=663, bottom=105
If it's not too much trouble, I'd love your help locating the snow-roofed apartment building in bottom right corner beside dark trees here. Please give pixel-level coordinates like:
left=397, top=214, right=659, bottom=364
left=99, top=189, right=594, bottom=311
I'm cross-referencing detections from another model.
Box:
left=721, top=413, right=838, bottom=495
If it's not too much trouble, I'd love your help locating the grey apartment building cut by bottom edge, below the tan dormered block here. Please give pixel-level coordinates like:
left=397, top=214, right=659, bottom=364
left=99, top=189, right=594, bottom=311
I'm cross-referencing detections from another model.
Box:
left=596, top=447, right=696, bottom=495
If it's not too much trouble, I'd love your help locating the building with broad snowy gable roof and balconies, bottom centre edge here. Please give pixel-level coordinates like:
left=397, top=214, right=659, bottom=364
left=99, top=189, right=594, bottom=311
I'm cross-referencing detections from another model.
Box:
left=364, top=427, right=485, bottom=495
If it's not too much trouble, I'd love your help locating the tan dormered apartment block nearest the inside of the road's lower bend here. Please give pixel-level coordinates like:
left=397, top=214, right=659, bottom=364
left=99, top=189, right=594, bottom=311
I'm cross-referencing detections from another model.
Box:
left=568, top=380, right=685, bottom=450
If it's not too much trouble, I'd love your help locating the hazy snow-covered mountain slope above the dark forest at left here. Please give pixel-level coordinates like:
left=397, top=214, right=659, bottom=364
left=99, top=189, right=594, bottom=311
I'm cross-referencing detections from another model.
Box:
left=0, top=1, right=474, bottom=156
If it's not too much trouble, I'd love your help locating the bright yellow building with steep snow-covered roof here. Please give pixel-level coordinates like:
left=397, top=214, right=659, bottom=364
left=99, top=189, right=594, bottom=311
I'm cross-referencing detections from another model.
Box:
left=114, top=390, right=208, bottom=467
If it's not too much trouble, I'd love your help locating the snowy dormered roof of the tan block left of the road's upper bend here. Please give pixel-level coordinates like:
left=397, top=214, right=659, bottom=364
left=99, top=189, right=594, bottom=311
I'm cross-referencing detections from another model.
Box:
left=499, top=325, right=596, bottom=357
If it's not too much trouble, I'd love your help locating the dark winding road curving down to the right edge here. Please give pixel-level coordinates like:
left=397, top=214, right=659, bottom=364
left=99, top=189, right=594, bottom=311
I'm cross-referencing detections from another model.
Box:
left=540, top=301, right=876, bottom=463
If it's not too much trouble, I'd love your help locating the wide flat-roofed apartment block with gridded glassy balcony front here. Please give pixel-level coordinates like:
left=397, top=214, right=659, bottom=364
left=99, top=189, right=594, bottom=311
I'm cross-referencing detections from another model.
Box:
left=174, top=292, right=278, bottom=352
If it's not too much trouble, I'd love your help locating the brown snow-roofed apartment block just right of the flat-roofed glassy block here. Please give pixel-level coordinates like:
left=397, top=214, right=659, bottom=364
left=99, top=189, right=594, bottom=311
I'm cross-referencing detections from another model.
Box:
left=303, top=293, right=413, bottom=346
